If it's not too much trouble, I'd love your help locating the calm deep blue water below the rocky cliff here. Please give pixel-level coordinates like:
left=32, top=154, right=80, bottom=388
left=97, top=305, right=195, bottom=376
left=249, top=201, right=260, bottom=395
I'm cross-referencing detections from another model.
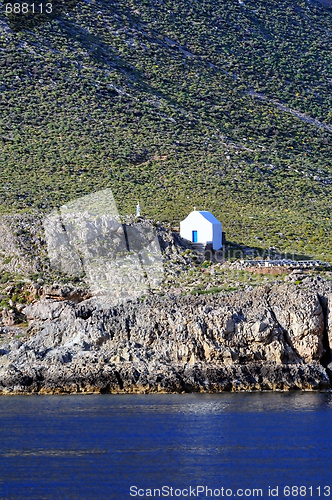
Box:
left=0, top=393, right=332, bottom=500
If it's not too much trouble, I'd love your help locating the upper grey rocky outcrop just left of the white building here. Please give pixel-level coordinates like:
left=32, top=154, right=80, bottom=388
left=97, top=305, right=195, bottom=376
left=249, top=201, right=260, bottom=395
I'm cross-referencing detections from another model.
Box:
left=0, top=214, right=192, bottom=286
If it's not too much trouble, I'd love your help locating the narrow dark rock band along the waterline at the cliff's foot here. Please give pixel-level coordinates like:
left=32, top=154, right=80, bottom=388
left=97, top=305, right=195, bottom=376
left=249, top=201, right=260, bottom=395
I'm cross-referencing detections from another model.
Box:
left=0, top=363, right=332, bottom=396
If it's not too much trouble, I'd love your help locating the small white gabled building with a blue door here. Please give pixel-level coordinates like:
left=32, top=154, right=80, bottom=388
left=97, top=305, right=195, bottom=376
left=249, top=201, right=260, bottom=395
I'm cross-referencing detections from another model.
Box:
left=180, top=210, right=222, bottom=250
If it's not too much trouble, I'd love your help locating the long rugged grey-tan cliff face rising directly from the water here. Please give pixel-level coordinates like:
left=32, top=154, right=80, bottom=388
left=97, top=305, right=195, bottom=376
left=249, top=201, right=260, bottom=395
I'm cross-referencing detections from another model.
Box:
left=0, top=278, right=332, bottom=393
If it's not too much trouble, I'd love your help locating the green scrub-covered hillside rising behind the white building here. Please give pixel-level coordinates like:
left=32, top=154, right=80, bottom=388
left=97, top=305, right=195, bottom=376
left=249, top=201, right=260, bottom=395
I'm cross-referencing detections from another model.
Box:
left=0, top=0, right=332, bottom=262
